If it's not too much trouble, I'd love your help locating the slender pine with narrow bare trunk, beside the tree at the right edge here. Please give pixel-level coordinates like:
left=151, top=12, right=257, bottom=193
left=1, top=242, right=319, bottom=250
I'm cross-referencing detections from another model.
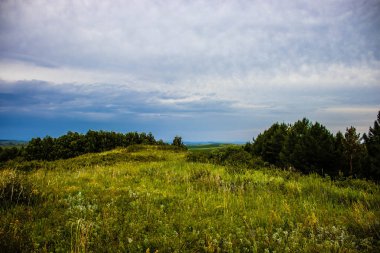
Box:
left=343, top=126, right=362, bottom=176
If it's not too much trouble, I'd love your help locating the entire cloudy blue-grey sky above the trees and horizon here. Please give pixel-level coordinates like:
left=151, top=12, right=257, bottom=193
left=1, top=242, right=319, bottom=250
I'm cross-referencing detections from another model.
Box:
left=0, top=0, right=380, bottom=142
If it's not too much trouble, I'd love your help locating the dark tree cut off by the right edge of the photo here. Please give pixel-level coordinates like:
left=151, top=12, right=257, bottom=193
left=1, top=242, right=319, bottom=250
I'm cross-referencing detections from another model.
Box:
left=363, top=111, right=380, bottom=180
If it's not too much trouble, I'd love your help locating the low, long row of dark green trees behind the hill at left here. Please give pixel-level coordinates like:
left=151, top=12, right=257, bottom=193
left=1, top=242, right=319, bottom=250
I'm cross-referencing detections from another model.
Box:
left=0, top=130, right=185, bottom=162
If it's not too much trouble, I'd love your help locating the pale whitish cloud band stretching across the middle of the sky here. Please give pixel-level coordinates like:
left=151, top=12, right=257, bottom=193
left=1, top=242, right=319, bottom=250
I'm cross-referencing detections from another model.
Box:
left=0, top=59, right=380, bottom=106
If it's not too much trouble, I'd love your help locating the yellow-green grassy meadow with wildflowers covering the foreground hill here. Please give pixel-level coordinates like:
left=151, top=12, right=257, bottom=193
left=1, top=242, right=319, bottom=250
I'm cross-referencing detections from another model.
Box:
left=0, top=147, right=380, bottom=252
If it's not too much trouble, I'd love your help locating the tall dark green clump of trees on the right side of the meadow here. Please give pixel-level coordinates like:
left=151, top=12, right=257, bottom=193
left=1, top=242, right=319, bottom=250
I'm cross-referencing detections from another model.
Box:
left=244, top=111, right=380, bottom=180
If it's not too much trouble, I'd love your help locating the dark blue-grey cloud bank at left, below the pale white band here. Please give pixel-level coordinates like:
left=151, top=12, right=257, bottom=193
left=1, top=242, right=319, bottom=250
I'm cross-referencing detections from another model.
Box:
left=0, top=81, right=236, bottom=120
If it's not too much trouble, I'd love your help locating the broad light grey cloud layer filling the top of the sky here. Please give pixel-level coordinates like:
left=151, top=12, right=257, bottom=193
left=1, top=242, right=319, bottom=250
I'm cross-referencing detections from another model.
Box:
left=0, top=1, right=380, bottom=81
